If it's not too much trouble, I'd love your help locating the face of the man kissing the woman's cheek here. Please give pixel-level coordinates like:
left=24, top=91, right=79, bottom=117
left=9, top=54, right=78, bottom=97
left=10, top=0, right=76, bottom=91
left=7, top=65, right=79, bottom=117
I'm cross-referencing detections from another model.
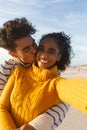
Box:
left=9, top=36, right=37, bottom=64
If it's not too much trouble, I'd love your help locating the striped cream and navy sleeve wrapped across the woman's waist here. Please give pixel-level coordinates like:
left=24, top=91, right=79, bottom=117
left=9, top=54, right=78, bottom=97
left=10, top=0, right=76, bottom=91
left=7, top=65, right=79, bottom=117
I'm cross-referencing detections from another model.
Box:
left=29, top=102, right=69, bottom=130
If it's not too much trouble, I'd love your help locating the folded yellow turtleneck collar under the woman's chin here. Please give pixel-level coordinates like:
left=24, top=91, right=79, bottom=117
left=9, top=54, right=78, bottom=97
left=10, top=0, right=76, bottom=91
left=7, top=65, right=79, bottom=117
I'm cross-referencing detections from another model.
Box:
left=31, top=64, right=58, bottom=81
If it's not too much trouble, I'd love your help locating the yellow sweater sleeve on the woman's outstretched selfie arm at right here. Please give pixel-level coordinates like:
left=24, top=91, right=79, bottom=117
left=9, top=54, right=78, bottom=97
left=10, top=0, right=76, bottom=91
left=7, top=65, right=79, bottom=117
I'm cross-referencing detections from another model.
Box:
left=56, top=78, right=87, bottom=114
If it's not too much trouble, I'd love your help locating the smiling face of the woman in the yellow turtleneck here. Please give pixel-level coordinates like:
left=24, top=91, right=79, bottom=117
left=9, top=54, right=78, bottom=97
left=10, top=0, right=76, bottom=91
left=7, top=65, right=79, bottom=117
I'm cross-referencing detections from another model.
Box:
left=37, top=38, right=61, bottom=69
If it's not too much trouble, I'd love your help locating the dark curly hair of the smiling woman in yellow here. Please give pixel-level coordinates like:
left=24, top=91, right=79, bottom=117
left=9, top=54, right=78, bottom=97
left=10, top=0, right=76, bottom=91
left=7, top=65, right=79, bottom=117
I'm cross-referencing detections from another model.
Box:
left=39, top=32, right=74, bottom=71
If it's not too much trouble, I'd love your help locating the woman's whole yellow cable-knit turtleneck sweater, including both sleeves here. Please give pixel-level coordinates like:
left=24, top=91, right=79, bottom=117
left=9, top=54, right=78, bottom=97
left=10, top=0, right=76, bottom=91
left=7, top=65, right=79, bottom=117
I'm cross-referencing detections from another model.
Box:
left=0, top=64, right=87, bottom=130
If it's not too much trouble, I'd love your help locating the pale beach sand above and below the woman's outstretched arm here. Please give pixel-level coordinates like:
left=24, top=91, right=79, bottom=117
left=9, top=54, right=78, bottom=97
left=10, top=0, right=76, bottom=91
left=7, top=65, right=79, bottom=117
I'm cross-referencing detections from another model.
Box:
left=55, top=66, right=87, bottom=130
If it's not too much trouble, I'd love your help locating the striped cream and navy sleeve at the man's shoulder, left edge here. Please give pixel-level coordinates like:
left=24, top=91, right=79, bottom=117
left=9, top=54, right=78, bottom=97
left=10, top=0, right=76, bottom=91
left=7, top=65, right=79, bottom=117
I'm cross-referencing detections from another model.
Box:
left=0, top=59, right=17, bottom=95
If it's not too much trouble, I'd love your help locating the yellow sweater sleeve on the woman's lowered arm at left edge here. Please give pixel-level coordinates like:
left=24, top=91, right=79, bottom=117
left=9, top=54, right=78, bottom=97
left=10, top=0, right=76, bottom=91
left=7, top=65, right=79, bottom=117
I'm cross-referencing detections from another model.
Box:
left=0, top=70, right=16, bottom=130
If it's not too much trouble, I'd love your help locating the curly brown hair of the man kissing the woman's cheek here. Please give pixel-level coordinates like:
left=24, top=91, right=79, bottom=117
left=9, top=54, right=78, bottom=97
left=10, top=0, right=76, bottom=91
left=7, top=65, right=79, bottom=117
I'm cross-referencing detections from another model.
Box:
left=0, top=17, right=36, bottom=50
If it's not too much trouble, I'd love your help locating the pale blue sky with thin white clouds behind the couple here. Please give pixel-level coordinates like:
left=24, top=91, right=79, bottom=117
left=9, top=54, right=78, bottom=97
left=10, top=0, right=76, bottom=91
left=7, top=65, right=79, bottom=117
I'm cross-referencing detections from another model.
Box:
left=0, top=0, right=87, bottom=65
